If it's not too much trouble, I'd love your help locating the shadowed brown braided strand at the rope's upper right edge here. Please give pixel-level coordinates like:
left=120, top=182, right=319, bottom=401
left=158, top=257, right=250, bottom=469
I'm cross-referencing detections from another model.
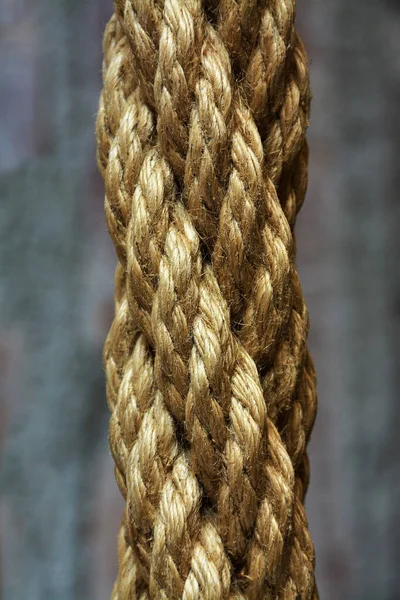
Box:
left=212, top=0, right=310, bottom=227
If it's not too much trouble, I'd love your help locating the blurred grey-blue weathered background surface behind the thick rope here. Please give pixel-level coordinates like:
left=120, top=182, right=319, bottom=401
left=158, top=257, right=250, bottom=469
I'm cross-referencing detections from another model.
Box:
left=0, top=0, right=400, bottom=600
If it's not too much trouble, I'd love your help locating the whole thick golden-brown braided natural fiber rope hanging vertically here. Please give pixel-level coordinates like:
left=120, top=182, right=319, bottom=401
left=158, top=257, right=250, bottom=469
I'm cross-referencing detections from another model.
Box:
left=97, top=0, right=317, bottom=600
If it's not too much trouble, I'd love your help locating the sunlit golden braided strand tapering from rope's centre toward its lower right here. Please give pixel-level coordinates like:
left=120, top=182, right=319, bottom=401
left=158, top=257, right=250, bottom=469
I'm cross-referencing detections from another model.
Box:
left=187, top=269, right=292, bottom=593
